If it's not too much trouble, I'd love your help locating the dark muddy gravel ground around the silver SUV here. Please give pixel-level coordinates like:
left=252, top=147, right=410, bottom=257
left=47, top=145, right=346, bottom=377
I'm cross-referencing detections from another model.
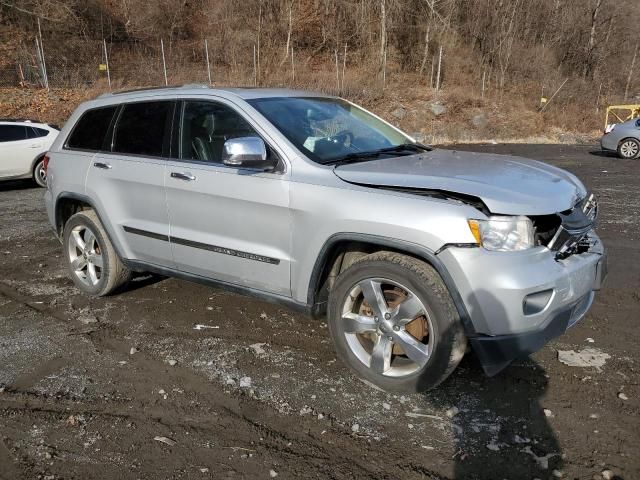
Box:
left=0, top=145, right=640, bottom=480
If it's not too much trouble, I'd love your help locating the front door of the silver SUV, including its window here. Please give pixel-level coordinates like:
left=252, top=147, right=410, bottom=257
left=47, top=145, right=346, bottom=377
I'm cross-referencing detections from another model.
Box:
left=165, top=100, right=291, bottom=296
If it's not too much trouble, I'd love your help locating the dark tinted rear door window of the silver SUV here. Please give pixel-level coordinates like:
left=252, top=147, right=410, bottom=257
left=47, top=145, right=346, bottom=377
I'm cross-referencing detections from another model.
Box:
left=112, top=101, right=174, bottom=157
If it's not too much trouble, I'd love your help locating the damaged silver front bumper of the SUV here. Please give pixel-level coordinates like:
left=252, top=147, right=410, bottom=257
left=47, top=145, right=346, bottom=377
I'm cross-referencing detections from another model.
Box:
left=438, top=232, right=607, bottom=375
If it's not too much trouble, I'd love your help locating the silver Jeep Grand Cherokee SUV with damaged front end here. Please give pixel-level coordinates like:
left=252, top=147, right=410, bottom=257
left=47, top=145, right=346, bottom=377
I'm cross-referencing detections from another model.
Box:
left=45, top=86, right=606, bottom=392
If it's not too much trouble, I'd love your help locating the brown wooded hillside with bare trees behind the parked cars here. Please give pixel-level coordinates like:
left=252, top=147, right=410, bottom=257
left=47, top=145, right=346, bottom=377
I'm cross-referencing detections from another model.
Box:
left=0, top=0, right=640, bottom=142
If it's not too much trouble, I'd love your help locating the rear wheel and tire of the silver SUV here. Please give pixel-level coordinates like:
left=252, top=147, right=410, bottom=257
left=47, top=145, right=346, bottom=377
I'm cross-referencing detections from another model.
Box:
left=63, top=210, right=131, bottom=297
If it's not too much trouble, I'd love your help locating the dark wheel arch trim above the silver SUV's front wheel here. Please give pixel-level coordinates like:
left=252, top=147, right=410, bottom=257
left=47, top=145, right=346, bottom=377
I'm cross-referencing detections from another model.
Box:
left=307, top=232, right=475, bottom=335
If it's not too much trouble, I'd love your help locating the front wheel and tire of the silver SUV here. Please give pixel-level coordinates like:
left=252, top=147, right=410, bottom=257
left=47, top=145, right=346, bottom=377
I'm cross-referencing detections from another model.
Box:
left=328, top=252, right=466, bottom=393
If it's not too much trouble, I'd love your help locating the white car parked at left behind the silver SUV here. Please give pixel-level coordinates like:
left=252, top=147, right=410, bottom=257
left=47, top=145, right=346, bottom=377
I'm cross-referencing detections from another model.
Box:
left=0, top=119, right=60, bottom=187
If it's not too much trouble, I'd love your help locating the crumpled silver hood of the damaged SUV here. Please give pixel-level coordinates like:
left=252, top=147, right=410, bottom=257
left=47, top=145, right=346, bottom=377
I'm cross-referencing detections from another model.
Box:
left=334, top=149, right=586, bottom=215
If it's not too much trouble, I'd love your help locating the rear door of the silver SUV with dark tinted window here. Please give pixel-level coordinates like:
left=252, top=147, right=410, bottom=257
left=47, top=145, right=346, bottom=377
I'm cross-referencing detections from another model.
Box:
left=87, top=100, right=175, bottom=267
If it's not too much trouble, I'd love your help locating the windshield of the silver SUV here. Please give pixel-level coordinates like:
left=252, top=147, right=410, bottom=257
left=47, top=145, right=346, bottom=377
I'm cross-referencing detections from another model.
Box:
left=249, top=97, right=413, bottom=164
